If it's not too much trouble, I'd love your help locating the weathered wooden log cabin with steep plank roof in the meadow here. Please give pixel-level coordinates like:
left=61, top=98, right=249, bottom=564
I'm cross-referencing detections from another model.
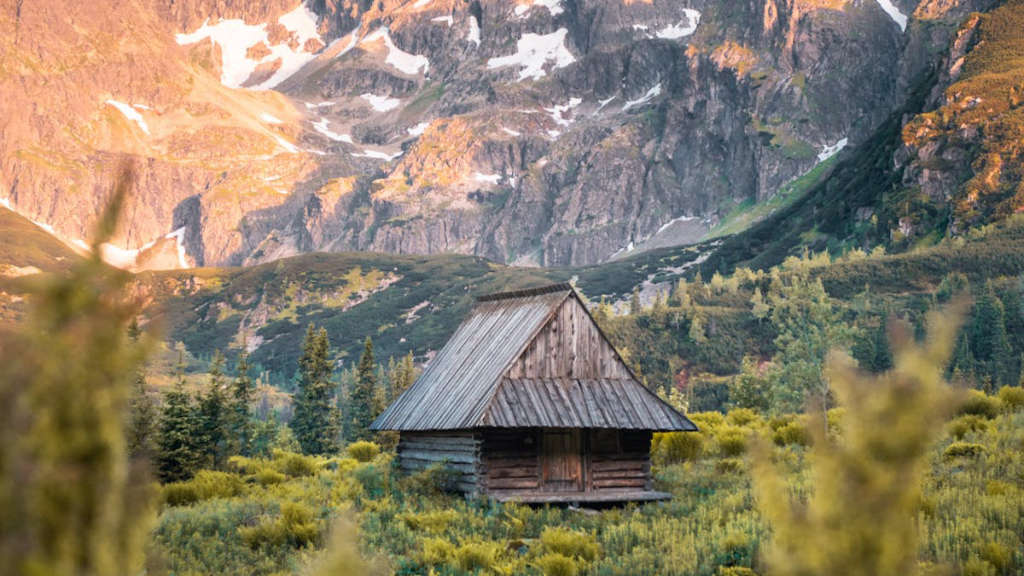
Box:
left=372, top=284, right=696, bottom=502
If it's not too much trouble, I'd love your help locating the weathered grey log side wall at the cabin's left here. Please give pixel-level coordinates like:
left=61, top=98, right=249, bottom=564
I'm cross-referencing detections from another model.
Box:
left=397, top=430, right=482, bottom=494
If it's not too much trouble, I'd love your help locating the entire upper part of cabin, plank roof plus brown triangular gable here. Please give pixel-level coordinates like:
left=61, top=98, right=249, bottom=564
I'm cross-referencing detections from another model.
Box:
left=371, top=284, right=696, bottom=430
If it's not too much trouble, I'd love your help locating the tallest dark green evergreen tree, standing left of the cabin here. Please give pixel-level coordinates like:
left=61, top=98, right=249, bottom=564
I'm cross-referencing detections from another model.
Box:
left=291, top=324, right=340, bottom=454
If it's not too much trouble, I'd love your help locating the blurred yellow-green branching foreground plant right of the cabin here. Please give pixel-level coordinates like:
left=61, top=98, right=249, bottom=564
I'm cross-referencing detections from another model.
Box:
left=755, top=305, right=963, bottom=576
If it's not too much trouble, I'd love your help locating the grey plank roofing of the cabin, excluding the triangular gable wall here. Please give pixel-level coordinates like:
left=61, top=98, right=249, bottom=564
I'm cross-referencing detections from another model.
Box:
left=371, top=284, right=696, bottom=430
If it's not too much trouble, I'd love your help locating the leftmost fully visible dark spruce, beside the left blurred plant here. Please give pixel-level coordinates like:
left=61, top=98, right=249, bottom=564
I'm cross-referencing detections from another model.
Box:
left=157, top=358, right=199, bottom=482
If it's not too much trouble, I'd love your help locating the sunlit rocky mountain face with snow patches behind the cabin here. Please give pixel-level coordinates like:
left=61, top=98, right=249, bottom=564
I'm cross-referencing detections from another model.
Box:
left=0, top=0, right=983, bottom=269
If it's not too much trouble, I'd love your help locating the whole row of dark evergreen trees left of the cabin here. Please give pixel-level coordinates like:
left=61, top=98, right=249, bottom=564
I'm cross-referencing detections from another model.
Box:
left=136, top=323, right=416, bottom=483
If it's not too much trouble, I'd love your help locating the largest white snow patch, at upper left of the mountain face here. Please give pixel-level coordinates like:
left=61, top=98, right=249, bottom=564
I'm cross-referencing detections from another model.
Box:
left=175, top=3, right=322, bottom=90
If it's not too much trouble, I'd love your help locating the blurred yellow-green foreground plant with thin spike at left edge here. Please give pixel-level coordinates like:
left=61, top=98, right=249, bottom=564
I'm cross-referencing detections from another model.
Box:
left=0, top=165, right=151, bottom=576
